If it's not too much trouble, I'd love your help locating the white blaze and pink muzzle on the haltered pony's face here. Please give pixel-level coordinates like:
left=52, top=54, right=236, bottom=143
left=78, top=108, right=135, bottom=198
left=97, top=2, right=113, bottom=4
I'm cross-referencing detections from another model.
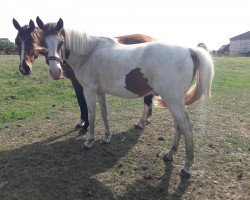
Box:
left=45, top=35, right=62, bottom=80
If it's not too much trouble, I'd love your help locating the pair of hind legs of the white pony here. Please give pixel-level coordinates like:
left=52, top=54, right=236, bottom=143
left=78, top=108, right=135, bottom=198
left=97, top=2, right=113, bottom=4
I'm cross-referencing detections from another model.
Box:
left=166, top=101, right=194, bottom=178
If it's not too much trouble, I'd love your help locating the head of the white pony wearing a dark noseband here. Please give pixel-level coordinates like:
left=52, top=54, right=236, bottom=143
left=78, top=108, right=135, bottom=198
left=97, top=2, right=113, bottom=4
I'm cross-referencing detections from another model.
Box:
left=36, top=17, right=64, bottom=80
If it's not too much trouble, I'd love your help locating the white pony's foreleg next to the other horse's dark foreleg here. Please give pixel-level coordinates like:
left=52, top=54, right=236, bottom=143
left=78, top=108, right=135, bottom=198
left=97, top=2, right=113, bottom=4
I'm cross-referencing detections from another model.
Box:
left=83, top=88, right=96, bottom=149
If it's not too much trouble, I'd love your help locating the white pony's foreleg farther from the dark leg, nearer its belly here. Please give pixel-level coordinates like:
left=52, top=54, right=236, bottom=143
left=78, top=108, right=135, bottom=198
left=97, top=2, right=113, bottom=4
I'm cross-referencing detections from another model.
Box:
left=98, top=94, right=110, bottom=144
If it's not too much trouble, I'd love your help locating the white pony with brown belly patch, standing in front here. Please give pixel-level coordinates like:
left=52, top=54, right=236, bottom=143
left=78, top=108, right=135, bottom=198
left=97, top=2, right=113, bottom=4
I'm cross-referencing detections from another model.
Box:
left=37, top=17, right=214, bottom=177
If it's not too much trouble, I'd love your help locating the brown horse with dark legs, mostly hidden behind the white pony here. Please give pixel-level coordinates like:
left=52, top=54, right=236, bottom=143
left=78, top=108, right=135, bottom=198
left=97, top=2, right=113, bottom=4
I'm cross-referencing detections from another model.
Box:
left=13, top=18, right=155, bottom=134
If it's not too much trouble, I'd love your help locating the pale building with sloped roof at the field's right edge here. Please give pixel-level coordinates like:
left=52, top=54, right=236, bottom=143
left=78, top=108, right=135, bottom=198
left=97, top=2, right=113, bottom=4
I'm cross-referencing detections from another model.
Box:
left=229, top=31, right=250, bottom=56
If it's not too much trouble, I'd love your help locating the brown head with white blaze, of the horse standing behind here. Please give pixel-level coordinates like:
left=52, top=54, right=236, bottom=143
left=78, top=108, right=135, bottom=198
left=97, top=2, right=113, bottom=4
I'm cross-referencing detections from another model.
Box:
left=12, top=18, right=41, bottom=75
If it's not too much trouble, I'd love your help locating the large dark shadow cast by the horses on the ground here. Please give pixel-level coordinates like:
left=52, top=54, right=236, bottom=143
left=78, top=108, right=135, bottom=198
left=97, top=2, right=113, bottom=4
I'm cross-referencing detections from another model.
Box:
left=0, top=126, right=188, bottom=200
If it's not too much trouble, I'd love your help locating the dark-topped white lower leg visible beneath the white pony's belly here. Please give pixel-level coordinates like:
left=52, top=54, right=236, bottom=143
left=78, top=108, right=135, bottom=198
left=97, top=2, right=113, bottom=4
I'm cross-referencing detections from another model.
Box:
left=135, top=95, right=153, bottom=129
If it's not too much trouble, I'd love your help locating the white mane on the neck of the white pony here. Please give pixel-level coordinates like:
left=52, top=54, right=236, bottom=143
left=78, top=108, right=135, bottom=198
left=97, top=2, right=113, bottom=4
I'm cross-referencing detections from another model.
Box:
left=64, top=28, right=91, bottom=55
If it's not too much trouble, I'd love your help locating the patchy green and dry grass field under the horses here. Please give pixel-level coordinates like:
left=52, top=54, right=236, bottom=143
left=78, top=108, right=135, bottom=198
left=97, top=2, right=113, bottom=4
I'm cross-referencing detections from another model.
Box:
left=0, top=56, right=250, bottom=200
